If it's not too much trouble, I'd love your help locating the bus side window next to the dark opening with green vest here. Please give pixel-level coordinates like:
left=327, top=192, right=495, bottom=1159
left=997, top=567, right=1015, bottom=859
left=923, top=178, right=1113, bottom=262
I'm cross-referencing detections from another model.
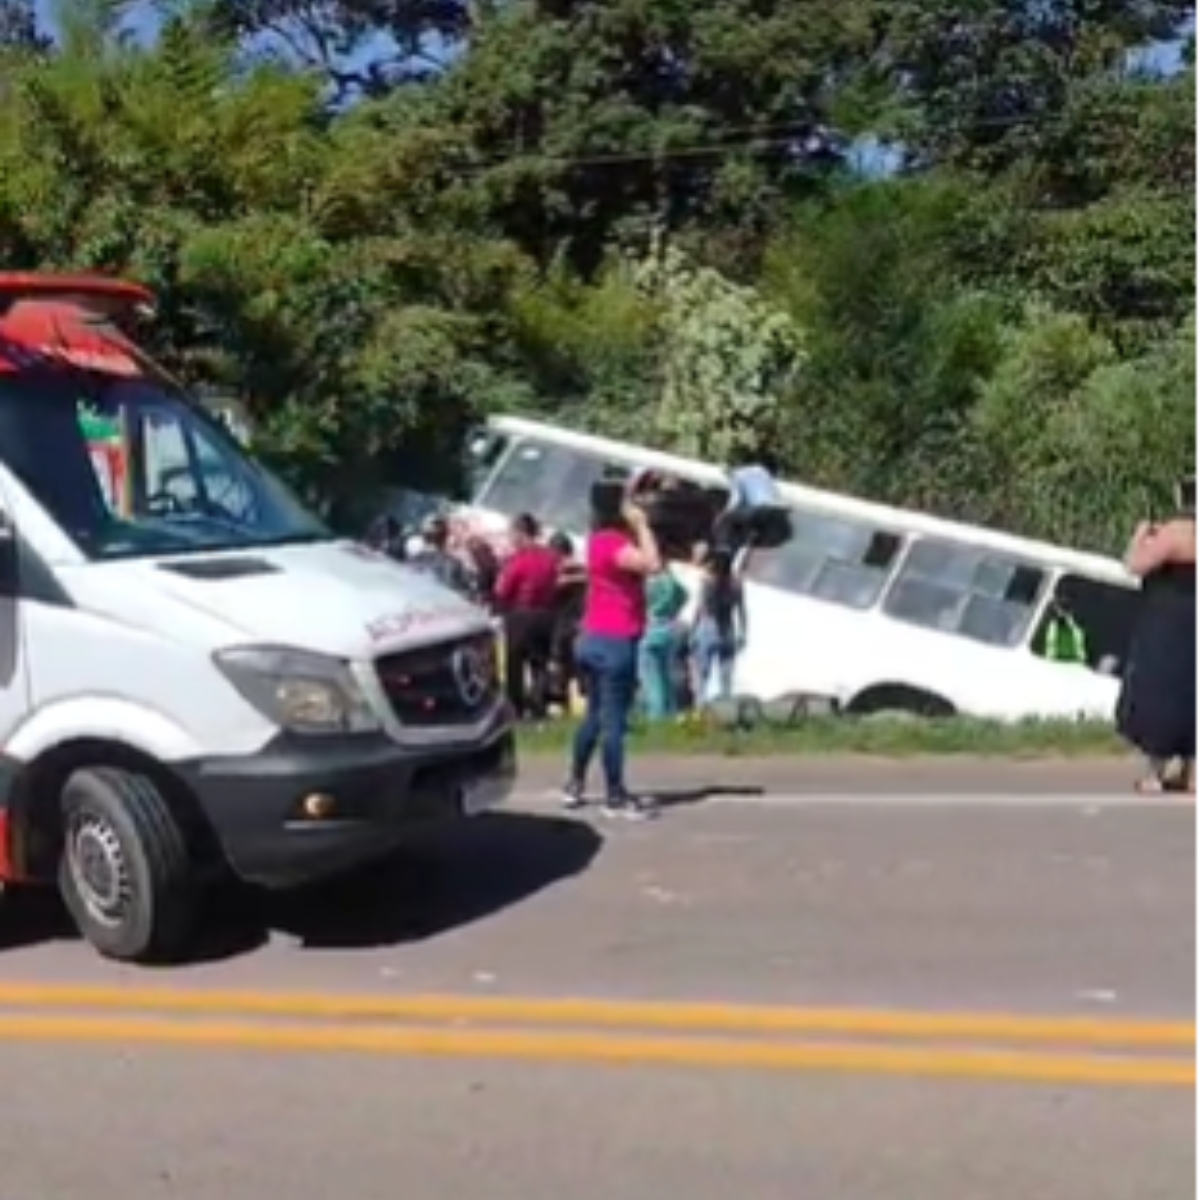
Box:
left=883, top=538, right=1045, bottom=647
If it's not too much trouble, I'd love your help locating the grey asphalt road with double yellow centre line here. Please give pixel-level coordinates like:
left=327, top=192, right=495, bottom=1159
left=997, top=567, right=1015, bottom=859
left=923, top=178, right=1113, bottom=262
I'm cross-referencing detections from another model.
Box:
left=0, top=758, right=1195, bottom=1200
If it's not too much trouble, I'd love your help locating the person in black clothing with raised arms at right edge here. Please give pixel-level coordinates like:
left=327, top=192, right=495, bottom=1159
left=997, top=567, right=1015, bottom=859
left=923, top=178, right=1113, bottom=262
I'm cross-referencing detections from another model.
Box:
left=1117, top=482, right=1196, bottom=794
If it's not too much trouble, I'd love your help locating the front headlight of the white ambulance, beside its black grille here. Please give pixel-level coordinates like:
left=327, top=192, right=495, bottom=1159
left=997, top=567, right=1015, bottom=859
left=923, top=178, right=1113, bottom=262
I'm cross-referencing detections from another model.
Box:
left=212, top=646, right=379, bottom=733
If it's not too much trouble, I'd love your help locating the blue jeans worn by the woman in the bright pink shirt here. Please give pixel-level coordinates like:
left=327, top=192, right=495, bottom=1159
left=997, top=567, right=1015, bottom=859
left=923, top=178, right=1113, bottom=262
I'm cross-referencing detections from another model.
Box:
left=571, top=634, right=637, bottom=797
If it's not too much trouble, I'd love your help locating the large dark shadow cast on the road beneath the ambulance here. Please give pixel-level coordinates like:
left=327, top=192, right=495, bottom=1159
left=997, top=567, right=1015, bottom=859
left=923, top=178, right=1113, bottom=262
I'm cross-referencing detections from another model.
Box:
left=0, top=812, right=602, bottom=964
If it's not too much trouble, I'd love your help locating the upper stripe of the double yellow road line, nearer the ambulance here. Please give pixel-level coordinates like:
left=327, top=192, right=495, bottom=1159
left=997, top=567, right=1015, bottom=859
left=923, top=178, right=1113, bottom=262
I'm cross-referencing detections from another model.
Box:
left=0, top=983, right=1195, bottom=1051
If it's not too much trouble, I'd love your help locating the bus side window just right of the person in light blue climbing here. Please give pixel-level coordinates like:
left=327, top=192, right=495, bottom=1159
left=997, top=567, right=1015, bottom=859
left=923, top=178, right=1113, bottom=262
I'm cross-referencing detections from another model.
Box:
left=746, top=509, right=902, bottom=611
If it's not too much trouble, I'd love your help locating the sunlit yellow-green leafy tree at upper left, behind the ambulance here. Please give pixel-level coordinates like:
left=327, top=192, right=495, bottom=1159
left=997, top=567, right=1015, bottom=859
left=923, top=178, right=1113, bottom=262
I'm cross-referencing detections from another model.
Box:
left=0, top=19, right=525, bottom=504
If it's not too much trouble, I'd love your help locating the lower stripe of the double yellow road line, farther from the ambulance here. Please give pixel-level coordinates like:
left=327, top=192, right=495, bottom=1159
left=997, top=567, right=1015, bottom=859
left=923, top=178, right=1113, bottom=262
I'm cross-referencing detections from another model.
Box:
left=0, top=1015, right=1195, bottom=1087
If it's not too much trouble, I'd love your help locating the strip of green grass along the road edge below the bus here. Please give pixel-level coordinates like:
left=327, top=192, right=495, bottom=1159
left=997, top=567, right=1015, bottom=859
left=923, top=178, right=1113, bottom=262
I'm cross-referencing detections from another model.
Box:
left=520, top=716, right=1128, bottom=758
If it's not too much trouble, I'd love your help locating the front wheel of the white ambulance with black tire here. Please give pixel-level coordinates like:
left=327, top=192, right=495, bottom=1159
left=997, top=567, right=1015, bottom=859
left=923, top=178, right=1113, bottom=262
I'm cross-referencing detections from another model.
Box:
left=59, top=767, right=199, bottom=962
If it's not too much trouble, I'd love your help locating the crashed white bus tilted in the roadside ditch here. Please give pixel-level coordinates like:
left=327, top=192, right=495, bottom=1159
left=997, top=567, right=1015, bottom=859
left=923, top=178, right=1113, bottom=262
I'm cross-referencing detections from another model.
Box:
left=448, top=416, right=1138, bottom=720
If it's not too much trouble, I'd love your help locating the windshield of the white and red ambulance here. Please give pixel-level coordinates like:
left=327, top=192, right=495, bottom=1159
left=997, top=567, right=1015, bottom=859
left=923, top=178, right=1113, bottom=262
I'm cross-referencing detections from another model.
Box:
left=0, top=366, right=330, bottom=560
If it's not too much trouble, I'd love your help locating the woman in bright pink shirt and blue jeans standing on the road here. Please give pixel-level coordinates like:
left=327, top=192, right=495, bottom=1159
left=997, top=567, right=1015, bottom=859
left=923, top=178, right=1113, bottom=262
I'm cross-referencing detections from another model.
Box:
left=563, top=496, right=662, bottom=820
